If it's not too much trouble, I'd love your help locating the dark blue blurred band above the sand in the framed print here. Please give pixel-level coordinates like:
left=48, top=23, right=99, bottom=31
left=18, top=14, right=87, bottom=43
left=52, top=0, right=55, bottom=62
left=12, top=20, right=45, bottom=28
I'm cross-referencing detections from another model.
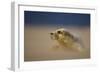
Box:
left=24, top=11, right=90, bottom=26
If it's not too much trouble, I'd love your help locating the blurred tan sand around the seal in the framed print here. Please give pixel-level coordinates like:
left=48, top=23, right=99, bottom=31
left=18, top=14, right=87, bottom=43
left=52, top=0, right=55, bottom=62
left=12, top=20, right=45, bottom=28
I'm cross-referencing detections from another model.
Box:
left=24, top=27, right=90, bottom=61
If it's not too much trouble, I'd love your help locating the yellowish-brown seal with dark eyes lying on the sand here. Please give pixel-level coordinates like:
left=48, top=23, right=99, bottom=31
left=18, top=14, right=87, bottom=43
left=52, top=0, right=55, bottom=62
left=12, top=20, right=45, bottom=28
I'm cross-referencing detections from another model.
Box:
left=50, top=28, right=82, bottom=51
